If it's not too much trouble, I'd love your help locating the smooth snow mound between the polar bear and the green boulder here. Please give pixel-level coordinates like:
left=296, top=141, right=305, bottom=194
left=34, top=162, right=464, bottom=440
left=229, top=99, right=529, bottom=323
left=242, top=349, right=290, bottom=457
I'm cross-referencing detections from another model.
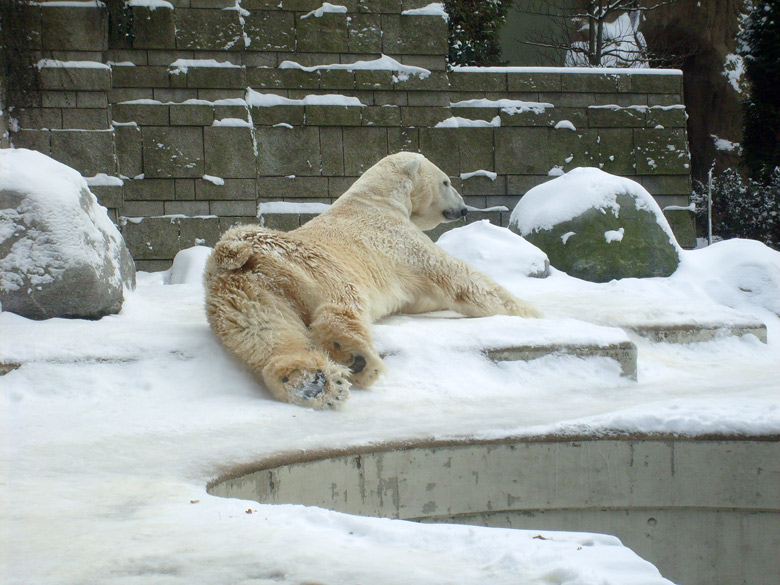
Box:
left=436, top=219, right=550, bottom=279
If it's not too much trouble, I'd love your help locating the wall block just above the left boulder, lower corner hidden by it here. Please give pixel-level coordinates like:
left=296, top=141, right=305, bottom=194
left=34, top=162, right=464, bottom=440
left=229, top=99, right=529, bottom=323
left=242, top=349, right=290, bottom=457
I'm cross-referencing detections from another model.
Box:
left=51, top=130, right=117, bottom=177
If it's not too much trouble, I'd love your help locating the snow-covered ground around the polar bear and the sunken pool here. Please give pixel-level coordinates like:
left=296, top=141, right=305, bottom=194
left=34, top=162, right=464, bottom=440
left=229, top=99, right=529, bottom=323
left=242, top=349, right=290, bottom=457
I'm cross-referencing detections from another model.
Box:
left=0, top=223, right=780, bottom=585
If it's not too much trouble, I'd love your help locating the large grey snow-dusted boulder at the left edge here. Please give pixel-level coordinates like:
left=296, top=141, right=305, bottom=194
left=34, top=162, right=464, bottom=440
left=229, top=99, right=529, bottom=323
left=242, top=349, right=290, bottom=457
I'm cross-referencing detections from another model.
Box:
left=0, top=149, right=135, bottom=319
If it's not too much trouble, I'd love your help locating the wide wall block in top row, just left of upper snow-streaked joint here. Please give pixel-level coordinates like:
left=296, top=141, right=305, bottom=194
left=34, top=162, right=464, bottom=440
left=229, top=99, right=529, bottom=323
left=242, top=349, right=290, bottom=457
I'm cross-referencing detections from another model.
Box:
left=174, top=8, right=244, bottom=51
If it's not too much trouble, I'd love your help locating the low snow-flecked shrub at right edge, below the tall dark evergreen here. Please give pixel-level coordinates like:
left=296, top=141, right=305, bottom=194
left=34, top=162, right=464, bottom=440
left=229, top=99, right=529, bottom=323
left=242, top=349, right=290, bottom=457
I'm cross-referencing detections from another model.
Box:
left=691, top=168, right=780, bottom=250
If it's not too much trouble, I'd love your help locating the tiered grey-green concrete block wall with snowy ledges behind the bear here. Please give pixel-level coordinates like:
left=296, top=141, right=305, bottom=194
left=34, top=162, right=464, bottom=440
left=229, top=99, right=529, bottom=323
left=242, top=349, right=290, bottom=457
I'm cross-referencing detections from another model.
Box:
left=4, top=0, right=692, bottom=269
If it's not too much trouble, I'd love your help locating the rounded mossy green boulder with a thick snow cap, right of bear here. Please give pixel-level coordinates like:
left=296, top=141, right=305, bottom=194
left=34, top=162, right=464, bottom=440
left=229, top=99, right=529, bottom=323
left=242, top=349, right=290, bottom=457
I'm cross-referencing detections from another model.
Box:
left=509, top=168, right=680, bottom=282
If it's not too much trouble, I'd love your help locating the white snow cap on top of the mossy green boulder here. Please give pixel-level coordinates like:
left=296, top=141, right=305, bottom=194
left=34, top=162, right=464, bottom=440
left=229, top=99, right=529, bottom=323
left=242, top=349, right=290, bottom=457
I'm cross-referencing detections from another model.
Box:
left=509, top=167, right=677, bottom=245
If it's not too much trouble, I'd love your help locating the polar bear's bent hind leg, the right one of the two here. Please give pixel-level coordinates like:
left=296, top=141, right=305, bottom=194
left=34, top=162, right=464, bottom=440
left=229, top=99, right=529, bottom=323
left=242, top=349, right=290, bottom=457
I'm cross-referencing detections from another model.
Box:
left=309, top=303, right=385, bottom=388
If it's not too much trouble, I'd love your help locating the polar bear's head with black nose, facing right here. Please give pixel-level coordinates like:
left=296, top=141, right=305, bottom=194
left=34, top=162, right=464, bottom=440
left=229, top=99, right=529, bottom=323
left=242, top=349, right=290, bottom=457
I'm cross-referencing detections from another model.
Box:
left=395, top=153, right=468, bottom=230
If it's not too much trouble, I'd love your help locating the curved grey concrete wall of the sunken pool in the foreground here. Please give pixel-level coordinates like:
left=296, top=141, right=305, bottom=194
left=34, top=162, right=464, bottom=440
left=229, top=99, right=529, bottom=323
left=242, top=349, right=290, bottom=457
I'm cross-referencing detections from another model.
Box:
left=210, top=437, right=780, bottom=585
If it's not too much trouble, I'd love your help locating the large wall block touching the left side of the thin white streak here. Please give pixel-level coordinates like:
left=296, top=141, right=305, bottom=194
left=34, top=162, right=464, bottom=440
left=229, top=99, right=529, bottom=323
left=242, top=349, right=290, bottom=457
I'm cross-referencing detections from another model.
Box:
left=203, top=126, right=257, bottom=179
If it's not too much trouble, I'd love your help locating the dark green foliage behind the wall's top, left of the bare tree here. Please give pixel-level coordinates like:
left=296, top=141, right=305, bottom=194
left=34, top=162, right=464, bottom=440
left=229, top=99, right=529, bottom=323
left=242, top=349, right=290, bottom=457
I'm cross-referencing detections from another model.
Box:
left=444, top=0, right=512, bottom=66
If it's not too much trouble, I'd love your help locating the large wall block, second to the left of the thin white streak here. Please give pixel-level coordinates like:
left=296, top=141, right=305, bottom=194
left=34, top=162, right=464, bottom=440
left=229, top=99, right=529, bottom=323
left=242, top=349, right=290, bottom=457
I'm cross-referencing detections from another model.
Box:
left=142, top=126, right=204, bottom=178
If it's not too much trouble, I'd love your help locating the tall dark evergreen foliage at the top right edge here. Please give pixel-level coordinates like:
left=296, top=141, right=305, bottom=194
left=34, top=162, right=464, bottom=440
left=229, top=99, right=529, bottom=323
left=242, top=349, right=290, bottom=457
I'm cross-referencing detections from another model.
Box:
left=742, top=0, right=780, bottom=180
